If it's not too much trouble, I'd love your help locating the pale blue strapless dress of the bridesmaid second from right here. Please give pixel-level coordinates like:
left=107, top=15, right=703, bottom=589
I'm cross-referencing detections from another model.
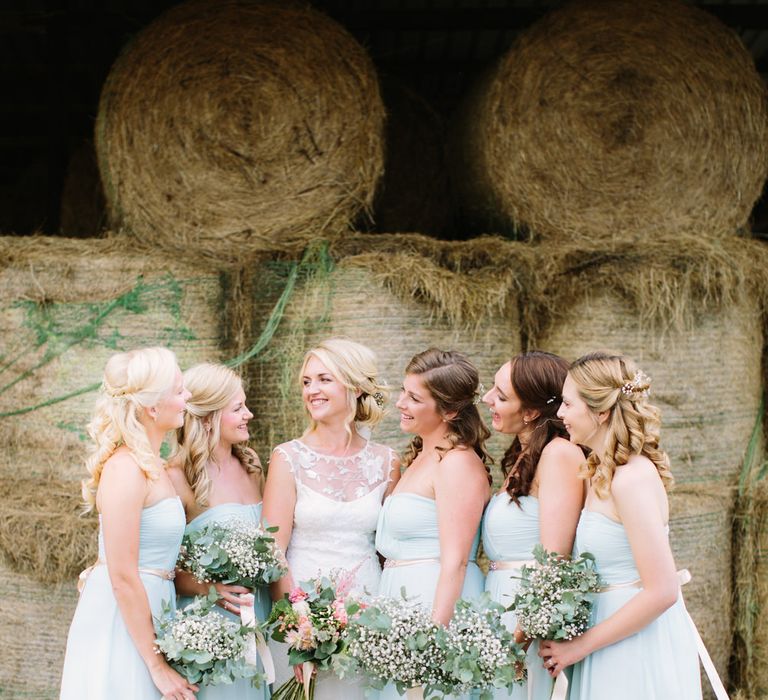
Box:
left=482, top=492, right=553, bottom=700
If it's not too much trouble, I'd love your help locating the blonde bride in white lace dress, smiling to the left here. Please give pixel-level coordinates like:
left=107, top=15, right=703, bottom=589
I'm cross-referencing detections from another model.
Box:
left=263, top=338, right=400, bottom=700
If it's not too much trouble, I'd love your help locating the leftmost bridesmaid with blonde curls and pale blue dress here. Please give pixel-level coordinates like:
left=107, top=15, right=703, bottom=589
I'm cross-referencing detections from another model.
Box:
left=60, top=348, right=197, bottom=700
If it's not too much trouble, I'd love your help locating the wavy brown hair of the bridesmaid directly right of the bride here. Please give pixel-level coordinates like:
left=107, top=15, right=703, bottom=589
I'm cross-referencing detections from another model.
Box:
left=403, top=348, right=493, bottom=483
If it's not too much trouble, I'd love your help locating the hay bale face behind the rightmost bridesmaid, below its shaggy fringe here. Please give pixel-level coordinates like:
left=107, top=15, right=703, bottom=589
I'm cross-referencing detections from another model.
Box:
left=535, top=285, right=763, bottom=486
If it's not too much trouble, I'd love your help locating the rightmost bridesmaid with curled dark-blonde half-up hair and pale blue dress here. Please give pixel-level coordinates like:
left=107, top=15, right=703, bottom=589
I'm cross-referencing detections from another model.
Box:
left=539, top=352, right=701, bottom=700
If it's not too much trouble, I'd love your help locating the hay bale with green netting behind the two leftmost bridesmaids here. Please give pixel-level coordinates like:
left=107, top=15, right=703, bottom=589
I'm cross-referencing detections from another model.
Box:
left=0, top=237, right=225, bottom=480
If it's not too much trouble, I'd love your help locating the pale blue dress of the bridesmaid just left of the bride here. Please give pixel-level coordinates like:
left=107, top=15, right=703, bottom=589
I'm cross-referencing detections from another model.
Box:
left=178, top=503, right=272, bottom=700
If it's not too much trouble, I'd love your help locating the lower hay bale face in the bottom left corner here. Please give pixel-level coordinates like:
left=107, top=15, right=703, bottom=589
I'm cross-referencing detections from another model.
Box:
left=0, top=563, right=77, bottom=700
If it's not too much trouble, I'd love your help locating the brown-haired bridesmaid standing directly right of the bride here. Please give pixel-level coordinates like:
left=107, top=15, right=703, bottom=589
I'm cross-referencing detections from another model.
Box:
left=376, top=348, right=491, bottom=698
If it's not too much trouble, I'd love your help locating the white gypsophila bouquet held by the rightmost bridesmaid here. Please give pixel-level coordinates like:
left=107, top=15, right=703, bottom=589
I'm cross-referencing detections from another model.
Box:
left=510, top=544, right=600, bottom=640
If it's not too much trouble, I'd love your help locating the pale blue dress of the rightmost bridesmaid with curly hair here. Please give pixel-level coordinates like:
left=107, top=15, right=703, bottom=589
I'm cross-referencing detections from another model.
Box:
left=569, top=510, right=702, bottom=700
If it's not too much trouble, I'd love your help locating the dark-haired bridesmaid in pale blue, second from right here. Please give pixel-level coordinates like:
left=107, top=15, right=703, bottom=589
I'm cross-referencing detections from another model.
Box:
left=483, top=351, right=584, bottom=700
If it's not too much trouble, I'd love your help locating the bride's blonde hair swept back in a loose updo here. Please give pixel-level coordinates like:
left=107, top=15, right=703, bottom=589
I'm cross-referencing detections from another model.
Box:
left=299, top=338, right=389, bottom=431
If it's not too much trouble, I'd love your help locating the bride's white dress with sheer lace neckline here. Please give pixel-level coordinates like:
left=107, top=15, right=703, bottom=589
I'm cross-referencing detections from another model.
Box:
left=270, top=440, right=395, bottom=700
